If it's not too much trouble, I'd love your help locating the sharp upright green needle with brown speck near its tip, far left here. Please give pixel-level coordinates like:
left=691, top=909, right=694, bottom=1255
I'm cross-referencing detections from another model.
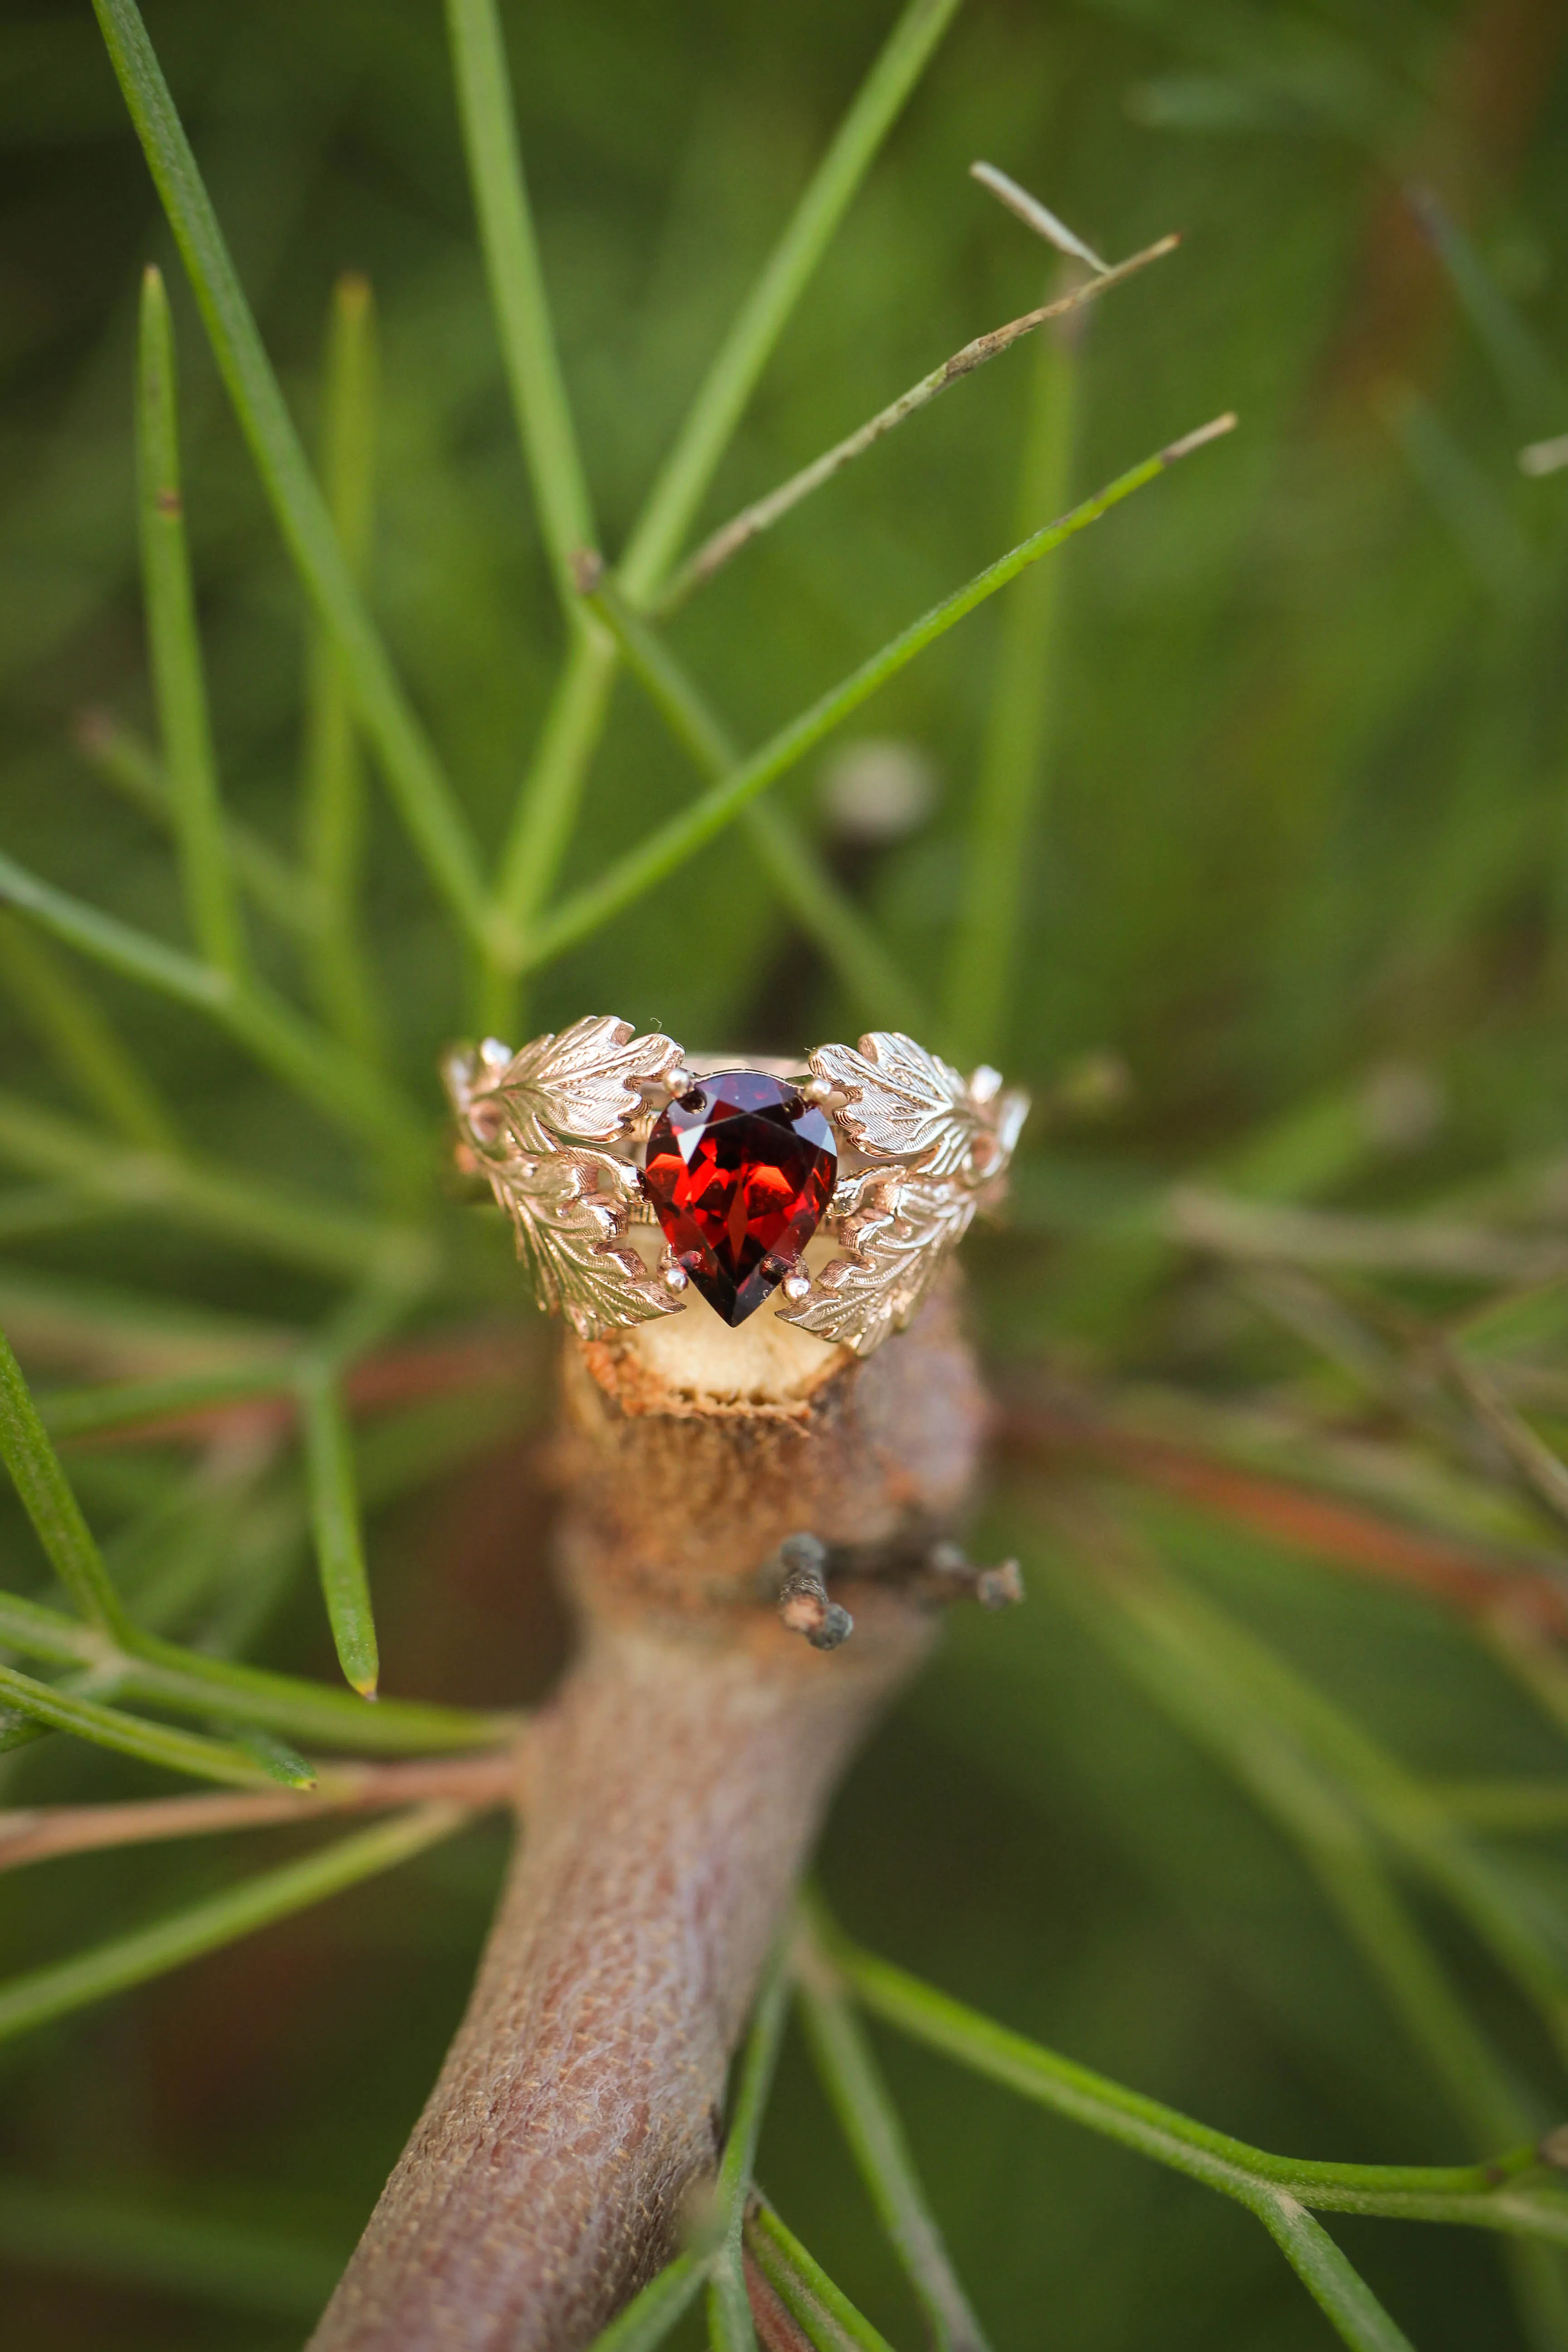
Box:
left=137, top=264, right=247, bottom=974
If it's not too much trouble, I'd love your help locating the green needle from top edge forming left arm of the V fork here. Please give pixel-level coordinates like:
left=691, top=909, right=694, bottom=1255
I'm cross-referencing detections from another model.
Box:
left=446, top=0, right=595, bottom=607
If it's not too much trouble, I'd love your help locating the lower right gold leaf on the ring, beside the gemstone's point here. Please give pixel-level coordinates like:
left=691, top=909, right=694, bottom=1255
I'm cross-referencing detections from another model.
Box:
left=778, top=1174, right=975, bottom=1355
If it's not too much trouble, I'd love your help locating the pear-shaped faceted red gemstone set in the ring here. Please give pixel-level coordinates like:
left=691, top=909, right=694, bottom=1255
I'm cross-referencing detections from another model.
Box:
left=642, top=1070, right=839, bottom=1327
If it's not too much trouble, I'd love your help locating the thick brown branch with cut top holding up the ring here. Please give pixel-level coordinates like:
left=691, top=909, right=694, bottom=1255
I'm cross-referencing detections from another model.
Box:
left=313, top=1303, right=980, bottom=2352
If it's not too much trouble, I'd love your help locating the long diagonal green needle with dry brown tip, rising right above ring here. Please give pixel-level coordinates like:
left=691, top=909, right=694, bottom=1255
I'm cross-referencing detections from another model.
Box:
left=545, top=416, right=1234, bottom=969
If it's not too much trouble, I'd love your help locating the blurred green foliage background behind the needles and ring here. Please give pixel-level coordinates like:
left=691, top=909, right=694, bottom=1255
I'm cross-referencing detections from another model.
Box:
left=0, top=0, right=1568, bottom=2352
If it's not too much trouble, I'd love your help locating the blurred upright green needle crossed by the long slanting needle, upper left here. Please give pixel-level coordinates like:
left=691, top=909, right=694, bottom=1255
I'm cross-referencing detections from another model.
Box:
left=301, top=270, right=386, bottom=1063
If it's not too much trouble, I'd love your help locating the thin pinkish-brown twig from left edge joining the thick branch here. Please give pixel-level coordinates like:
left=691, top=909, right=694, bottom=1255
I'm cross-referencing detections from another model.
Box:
left=0, top=1748, right=522, bottom=1870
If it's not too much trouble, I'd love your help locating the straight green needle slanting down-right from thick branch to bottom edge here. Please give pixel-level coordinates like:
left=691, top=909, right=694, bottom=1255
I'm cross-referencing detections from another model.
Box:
left=794, top=1910, right=985, bottom=2352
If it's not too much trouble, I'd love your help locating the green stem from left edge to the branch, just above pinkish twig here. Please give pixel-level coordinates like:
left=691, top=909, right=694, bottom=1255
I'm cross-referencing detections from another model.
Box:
left=0, top=1592, right=517, bottom=1754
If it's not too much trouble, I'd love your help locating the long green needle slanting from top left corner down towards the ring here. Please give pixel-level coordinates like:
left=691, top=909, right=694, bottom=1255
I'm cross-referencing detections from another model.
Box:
left=94, top=0, right=489, bottom=941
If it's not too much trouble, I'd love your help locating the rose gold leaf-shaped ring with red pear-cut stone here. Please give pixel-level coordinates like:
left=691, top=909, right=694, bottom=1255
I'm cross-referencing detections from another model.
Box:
left=442, top=1014, right=1029, bottom=1355
